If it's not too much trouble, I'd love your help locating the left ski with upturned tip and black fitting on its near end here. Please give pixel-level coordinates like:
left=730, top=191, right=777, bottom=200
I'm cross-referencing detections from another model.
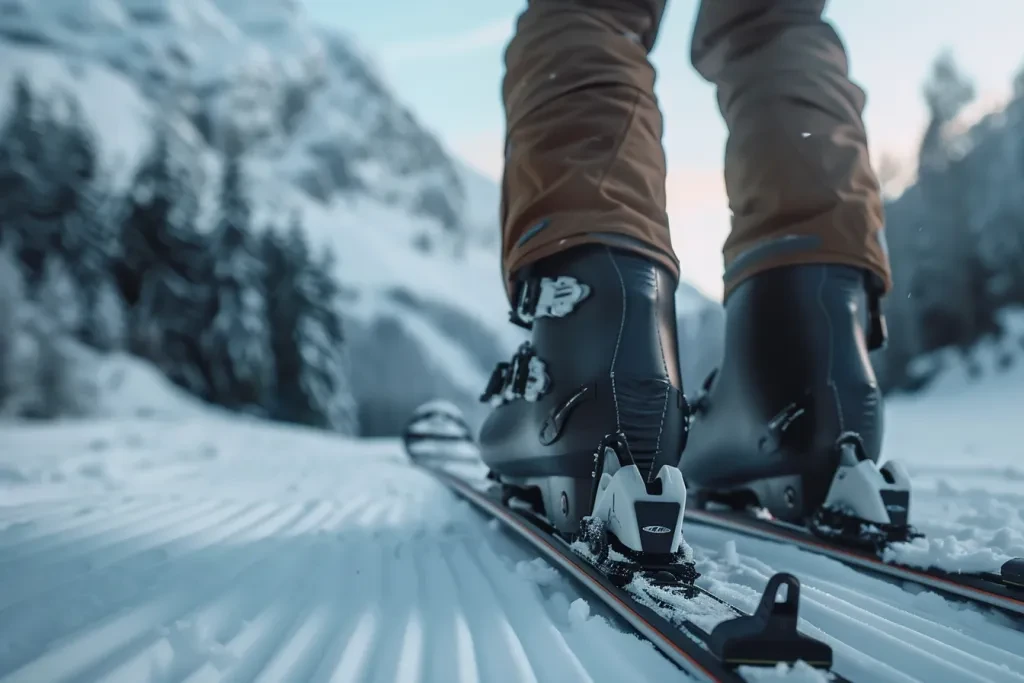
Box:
left=403, top=401, right=846, bottom=682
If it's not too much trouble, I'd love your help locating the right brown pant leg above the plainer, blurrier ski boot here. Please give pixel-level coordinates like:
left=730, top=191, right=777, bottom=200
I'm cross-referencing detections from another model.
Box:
left=691, top=0, right=892, bottom=296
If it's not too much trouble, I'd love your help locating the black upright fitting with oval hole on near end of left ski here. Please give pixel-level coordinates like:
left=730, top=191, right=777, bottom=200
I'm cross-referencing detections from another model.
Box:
left=710, top=572, right=833, bottom=669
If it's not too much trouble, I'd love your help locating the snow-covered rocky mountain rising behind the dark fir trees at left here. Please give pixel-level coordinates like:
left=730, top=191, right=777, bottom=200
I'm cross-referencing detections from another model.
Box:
left=0, top=0, right=717, bottom=434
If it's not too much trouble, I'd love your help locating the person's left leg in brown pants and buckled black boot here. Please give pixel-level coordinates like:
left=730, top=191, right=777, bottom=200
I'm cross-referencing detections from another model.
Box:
left=479, top=0, right=687, bottom=543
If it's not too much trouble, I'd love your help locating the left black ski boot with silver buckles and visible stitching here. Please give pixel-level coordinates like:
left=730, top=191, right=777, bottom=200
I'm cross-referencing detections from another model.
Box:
left=479, top=246, right=688, bottom=554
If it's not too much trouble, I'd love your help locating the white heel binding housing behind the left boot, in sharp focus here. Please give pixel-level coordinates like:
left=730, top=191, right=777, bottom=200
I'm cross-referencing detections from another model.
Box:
left=591, top=448, right=686, bottom=554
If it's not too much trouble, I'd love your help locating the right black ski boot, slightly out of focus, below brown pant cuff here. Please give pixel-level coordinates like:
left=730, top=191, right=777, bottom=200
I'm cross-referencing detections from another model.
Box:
left=680, top=265, right=909, bottom=531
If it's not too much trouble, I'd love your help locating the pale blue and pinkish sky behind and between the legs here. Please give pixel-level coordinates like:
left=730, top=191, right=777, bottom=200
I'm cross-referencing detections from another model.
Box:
left=305, top=0, right=1024, bottom=296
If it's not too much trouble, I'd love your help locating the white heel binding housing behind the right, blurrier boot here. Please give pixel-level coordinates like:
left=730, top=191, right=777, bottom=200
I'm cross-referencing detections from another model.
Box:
left=824, top=460, right=910, bottom=524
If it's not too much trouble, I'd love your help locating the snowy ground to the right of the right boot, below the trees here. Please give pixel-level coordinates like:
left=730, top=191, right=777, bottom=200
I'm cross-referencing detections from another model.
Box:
left=884, top=323, right=1024, bottom=573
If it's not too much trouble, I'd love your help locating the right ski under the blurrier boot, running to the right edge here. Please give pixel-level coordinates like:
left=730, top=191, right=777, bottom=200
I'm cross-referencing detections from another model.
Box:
left=686, top=508, right=1024, bottom=617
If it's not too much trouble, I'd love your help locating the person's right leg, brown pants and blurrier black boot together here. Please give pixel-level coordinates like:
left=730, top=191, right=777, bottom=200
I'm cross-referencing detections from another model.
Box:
left=680, top=0, right=905, bottom=528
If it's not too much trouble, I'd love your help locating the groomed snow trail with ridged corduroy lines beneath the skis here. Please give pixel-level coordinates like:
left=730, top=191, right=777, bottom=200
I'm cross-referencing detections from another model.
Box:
left=0, top=418, right=1024, bottom=683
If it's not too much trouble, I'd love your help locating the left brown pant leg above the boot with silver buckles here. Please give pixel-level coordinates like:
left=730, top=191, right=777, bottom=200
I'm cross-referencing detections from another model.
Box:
left=501, top=0, right=679, bottom=299
